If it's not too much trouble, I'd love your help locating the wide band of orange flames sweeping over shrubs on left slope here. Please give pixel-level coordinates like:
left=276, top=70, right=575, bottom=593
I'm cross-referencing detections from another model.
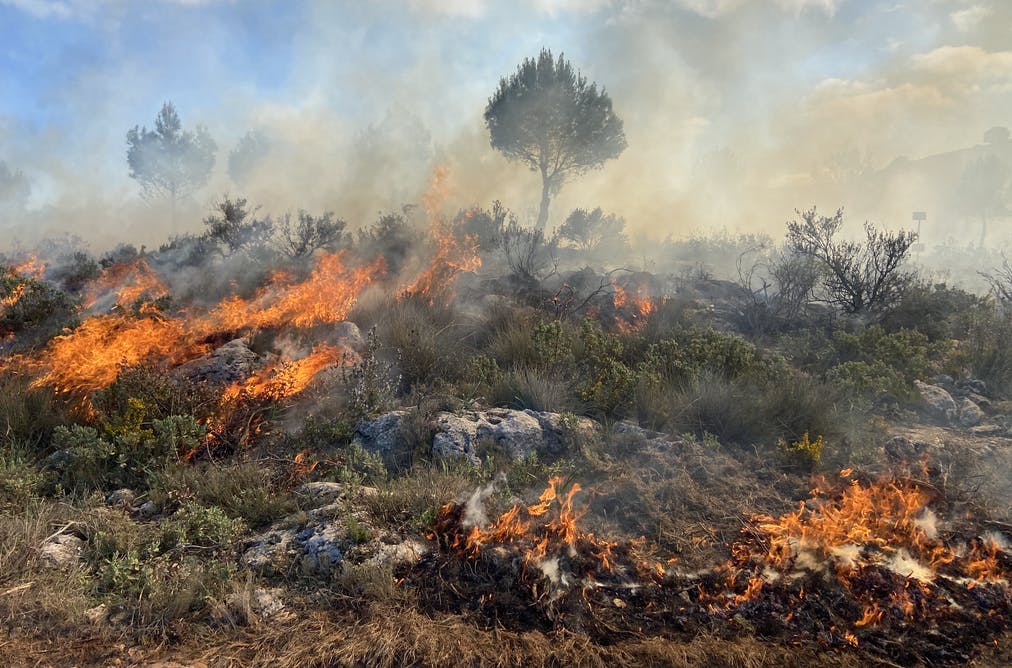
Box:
left=28, top=247, right=386, bottom=398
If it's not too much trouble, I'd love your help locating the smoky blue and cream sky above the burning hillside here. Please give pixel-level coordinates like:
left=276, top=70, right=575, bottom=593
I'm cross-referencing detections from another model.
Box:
left=0, top=0, right=1012, bottom=249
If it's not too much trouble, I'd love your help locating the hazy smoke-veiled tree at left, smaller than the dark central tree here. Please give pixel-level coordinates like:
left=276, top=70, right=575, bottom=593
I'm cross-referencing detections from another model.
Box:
left=127, top=102, right=218, bottom=221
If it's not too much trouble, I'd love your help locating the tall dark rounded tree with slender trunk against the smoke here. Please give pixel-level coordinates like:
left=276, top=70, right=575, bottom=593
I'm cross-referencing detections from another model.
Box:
left=485, top=49, right=626, bottom=228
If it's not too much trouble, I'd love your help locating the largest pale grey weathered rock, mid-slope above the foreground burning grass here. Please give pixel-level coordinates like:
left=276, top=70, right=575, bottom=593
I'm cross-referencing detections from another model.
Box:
left=432, top=408, right=594, bottom=464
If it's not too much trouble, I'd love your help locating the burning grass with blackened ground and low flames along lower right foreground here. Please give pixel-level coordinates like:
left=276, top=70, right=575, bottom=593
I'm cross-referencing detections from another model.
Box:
left=420, top=472, right=1012, bottom=664
